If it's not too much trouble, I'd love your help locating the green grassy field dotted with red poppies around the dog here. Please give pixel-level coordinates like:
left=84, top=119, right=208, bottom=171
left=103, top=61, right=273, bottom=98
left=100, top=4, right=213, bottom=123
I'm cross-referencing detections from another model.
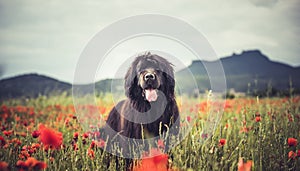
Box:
left=0, top=95, right=300, bottom=171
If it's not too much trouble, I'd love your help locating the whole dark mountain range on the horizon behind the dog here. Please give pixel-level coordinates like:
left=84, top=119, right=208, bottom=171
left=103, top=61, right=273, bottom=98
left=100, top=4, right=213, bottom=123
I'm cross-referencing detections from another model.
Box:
left=0, top=50, right=300, bottom=101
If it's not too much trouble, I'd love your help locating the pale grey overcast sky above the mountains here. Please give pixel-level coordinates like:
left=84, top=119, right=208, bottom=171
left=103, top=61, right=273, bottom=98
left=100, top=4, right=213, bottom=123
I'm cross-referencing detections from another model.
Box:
left=0, top=0, right=300, bottom=83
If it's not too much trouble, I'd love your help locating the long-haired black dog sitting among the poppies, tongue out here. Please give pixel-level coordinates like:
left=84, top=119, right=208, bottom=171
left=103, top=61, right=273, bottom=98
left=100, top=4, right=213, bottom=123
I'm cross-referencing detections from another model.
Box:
left=103, top=53, right=180, bottom=157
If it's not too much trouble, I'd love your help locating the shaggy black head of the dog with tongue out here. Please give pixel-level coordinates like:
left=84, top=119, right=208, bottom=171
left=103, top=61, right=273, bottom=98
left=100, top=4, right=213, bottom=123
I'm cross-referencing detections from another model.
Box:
left=125, top=53, right=175, bottom=102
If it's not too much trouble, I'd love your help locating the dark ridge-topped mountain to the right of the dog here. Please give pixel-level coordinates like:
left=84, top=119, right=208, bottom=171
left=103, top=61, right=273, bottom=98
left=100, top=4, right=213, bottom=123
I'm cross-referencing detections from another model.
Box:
left=176, top=50, right=300, bottom=93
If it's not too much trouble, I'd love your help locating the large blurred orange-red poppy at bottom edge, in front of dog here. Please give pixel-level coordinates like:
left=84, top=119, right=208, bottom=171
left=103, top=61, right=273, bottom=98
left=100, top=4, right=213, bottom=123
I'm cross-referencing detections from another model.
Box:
left=133, top=149, right=168, bottom=171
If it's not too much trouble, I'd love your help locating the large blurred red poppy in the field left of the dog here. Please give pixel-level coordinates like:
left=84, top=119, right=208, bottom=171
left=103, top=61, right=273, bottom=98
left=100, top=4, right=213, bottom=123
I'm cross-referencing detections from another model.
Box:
left=39, top=124, right=63, bottom=149
